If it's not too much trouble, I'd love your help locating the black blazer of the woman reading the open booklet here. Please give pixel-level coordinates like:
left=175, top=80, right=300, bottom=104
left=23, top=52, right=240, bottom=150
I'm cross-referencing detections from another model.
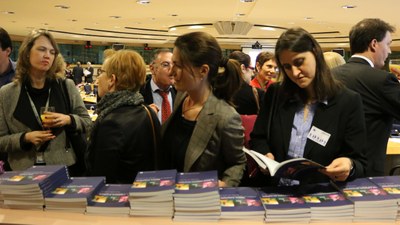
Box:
left=250, top=84, right=366, bottom=183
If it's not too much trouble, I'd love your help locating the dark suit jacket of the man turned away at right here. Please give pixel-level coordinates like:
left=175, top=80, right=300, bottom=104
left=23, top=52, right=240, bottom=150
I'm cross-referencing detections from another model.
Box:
left=332, top=57, right=400, bottom=176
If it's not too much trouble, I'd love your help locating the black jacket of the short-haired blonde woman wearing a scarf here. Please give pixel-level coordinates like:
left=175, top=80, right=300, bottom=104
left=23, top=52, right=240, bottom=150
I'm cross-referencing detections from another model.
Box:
left=86, top=105, right=160, bottom=184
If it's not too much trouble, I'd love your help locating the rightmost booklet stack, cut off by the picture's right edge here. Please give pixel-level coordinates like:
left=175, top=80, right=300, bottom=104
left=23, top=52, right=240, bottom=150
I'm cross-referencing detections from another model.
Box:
left=369, top=176, right=400, bottom=221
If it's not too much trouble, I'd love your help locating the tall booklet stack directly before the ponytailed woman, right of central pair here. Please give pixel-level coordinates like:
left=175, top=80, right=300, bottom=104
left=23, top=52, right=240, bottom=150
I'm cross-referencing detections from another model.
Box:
left=173, top=171, right=221, bottom=221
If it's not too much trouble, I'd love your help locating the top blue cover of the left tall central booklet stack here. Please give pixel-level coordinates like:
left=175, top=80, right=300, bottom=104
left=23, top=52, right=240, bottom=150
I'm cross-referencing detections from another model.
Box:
left=130, top=170, right=177, bottom=193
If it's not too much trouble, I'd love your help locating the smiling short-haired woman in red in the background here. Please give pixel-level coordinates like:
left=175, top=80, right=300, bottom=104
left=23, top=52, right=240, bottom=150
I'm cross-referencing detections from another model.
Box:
left=250, top=52, right=277, bottom=91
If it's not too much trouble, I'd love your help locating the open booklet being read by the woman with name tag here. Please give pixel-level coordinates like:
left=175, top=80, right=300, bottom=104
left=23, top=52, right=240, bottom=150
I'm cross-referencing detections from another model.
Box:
left=243, top=147, right=325, bottom=180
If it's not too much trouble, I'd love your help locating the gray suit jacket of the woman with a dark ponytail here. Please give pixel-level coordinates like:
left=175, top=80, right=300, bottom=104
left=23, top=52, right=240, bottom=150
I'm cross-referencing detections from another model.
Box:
left=162, top=92, right=246, bottom=186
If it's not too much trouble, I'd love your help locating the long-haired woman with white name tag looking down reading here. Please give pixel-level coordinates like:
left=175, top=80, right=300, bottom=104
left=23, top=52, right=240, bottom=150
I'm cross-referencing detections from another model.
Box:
left=251, top=28, right=366, bottom=184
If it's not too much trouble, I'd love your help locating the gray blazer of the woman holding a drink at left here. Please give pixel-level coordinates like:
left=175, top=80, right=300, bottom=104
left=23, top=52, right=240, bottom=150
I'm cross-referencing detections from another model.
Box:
left=0, top=79, right=92, bottom=170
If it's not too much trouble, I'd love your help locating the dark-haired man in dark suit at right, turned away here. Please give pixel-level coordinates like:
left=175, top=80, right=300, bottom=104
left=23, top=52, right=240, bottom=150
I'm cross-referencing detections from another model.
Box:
left=332, top=19, right=400, bottom=176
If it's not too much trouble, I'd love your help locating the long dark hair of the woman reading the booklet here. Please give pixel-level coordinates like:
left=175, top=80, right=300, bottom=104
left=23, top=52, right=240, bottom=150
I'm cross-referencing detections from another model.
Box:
left=275, top=28, right=341, bottom=102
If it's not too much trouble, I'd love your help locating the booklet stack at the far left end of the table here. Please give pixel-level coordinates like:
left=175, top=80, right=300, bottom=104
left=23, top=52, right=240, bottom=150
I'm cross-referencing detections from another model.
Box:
left=0, top=165, right=69, bottom=210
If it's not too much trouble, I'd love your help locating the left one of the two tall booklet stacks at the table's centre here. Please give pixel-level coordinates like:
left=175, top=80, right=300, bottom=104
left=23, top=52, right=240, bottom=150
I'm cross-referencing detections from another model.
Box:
left=129, top=170, right=177, bottom=218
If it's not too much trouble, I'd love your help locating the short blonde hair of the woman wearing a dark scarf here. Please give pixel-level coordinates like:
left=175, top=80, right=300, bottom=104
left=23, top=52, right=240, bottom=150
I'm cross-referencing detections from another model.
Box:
left=103, top=50, right=146, bottom=92
